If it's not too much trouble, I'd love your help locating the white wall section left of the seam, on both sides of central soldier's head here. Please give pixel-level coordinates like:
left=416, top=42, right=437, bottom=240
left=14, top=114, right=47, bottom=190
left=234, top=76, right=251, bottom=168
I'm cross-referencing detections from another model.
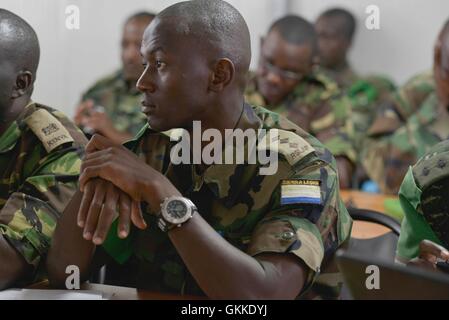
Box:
left=0, top=0, right=286, bottom=115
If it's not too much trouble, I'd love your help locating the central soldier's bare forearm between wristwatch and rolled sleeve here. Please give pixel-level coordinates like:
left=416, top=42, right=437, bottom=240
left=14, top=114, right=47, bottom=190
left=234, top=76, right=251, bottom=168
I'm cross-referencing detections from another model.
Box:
left=169, top=214, right=305, bottom=299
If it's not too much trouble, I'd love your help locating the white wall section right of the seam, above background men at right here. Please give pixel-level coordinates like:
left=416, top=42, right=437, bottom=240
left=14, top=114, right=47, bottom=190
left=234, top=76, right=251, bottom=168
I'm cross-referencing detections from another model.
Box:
left=292, top=0, right=449, bottom=84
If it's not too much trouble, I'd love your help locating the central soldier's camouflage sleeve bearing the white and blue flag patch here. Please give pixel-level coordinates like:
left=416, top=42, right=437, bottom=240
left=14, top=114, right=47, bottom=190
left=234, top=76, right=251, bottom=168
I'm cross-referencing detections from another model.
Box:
left=247, top=160, right=351, bottom=288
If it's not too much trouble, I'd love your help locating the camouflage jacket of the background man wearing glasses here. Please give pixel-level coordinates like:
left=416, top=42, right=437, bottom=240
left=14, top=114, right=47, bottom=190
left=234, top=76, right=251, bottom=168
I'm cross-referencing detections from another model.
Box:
left=245, top=68, right=357, bottom=163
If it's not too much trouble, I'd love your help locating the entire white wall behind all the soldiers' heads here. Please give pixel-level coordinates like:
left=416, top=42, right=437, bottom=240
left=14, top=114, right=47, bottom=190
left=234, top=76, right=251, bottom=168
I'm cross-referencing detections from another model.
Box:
left=0, top=0, right=449, bottom=115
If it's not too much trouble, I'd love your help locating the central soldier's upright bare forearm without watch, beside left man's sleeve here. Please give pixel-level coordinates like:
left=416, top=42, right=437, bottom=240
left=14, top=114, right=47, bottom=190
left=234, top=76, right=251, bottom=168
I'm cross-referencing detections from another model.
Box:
left=47, top=191, right=95, bottom=287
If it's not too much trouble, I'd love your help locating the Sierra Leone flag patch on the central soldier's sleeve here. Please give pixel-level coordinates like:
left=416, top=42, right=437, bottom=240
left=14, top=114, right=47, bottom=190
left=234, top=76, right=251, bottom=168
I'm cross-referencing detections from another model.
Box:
left=281, top=179, right=321, bottom=205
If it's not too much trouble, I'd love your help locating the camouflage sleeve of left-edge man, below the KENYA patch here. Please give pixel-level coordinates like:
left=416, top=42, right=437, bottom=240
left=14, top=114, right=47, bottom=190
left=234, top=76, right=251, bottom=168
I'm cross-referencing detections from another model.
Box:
left=0, top=145, right=82, bottom=268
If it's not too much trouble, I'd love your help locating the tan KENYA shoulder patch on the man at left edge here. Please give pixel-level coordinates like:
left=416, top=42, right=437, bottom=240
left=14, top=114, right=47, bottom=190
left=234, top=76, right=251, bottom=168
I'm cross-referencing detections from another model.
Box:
left=25, top=109, right=74, bottom=152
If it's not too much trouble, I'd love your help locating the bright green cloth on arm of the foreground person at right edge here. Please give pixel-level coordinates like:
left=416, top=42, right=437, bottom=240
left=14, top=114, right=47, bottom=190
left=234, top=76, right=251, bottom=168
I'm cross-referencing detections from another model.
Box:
left=396, top=168, right=441, bottom=262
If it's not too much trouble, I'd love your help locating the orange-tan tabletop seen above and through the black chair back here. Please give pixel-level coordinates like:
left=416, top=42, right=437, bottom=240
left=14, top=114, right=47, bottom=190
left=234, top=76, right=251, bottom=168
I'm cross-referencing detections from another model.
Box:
left=340, top=190, right=398, bottom=239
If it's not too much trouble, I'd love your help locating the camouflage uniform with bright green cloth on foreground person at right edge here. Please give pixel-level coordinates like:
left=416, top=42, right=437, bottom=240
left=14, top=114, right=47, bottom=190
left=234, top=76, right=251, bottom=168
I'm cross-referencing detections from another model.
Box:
left=397, top=140, right=449, bottom=262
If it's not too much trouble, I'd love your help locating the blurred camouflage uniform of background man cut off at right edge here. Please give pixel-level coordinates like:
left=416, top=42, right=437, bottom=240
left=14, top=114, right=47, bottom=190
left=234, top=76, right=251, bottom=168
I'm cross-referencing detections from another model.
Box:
left=362, top=74, right=440, bottom=193
